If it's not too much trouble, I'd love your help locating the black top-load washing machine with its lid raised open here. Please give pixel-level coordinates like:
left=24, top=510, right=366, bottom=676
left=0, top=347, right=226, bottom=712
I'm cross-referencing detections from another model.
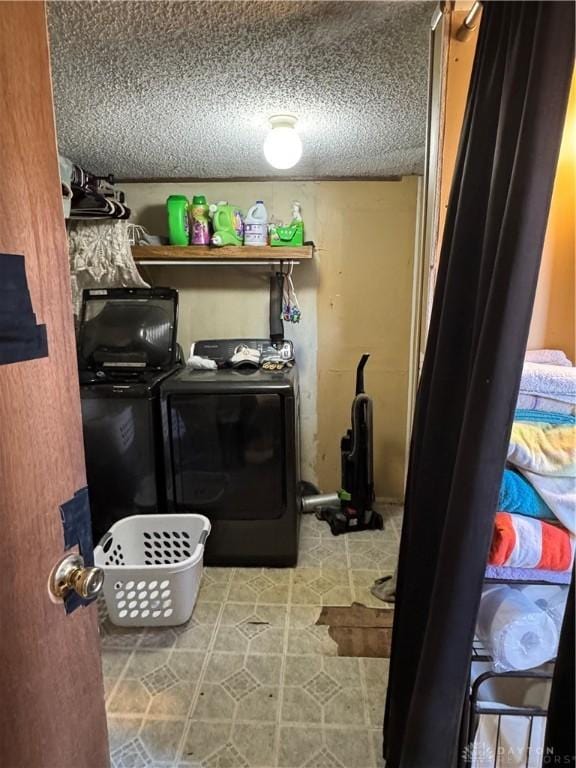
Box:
left=78, top=288, right=181, bottom=541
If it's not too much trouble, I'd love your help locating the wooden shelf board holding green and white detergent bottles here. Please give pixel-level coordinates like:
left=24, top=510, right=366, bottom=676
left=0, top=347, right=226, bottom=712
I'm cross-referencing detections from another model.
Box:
left=132, top=245, right=314, bottom=264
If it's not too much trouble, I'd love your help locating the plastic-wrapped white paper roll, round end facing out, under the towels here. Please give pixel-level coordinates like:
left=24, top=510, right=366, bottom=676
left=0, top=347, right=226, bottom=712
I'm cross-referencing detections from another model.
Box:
left=477, top=586, right=558, bottom=670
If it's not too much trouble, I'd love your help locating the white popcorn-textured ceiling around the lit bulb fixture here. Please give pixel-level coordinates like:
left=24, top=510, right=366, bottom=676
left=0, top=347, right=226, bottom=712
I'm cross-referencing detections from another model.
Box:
left=49, top=0, right=433, bottom=178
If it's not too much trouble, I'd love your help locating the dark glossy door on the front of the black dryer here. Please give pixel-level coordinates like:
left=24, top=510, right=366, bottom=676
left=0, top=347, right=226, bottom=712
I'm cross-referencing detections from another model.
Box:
left=168, top=393, right=286, bottom=520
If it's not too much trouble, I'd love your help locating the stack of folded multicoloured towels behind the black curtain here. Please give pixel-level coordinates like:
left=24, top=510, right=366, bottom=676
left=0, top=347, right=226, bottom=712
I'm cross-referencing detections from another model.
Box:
left=489, top=350, right=576, bottom=572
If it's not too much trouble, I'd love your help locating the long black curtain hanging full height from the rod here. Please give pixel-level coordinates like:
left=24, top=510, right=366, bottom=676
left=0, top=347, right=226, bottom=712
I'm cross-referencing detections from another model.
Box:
left=384, top=2, right=575, bottom=768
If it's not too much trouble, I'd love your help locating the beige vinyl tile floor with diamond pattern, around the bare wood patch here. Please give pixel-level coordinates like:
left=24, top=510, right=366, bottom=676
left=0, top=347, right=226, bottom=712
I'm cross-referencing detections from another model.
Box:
left=101, top=505, right=402, bottom=768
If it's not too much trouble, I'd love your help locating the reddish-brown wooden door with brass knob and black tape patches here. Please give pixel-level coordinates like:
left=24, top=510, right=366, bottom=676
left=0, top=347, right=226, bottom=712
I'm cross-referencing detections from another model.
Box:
left=0, top=2, right=108, bottom=768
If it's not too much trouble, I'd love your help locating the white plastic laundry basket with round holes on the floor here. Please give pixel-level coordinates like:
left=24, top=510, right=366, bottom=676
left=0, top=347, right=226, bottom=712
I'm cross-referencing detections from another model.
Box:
left=94, top=514, right=210, bottom=627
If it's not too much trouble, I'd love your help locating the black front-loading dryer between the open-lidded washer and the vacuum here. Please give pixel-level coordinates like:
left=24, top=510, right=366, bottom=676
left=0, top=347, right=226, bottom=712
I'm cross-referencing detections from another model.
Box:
left=160, top=339, right=300, bottom=566
